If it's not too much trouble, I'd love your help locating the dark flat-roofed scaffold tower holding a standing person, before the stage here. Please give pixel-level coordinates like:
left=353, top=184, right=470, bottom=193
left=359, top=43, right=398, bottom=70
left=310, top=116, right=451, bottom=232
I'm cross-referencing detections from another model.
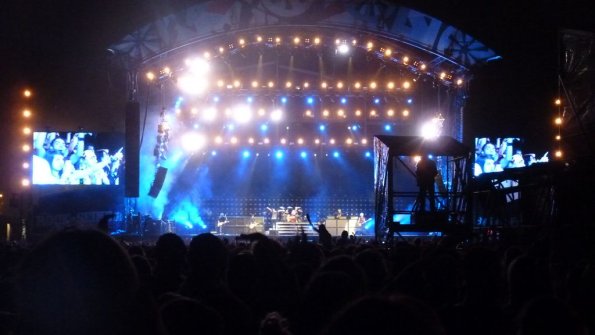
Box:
left=374, top=135, right=472, bottom=240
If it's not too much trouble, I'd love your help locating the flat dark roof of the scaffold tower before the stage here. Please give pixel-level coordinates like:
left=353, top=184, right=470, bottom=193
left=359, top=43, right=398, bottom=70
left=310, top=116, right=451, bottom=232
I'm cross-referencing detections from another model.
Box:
left=374, top=135, right=471, bottom=156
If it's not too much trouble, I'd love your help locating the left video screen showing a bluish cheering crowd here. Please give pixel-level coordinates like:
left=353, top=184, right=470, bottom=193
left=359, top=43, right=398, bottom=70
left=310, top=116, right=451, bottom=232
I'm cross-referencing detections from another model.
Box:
left=31, top=131, right=125, bottom=185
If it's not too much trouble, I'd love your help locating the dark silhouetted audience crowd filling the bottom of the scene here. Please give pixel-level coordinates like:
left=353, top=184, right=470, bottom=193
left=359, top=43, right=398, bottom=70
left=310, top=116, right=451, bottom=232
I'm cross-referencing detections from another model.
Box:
left=0, top=214, right=595, bottom=335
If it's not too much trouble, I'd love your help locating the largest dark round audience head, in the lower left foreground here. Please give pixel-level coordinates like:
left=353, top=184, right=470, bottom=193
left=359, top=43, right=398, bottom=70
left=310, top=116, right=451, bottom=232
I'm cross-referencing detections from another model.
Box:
left=16, top=229, right=138, bottom=334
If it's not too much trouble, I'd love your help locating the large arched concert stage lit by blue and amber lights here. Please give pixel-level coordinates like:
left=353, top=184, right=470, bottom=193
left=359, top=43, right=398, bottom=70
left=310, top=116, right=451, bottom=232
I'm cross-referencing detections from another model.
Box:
left=14, top=1, right=510, bottom=244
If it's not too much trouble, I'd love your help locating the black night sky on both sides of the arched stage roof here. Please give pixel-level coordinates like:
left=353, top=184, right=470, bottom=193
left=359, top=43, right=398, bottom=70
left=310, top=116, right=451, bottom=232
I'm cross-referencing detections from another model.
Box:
left=0, top=0, right=595, bottom=192
